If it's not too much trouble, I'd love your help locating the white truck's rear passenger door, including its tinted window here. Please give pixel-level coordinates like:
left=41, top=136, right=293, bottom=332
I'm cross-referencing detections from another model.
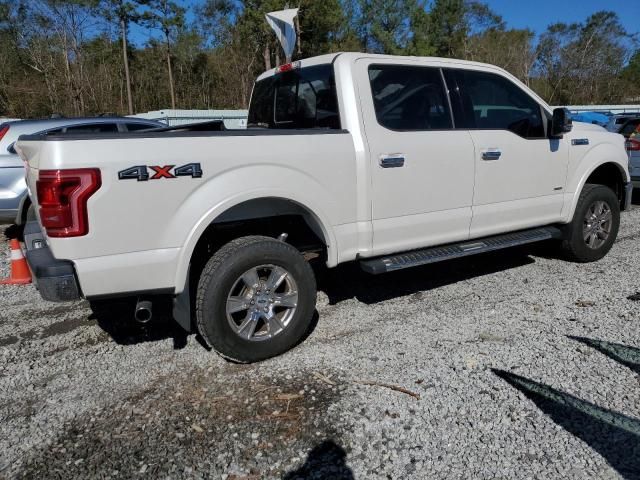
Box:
left=356, top=59, right=474, bottom=255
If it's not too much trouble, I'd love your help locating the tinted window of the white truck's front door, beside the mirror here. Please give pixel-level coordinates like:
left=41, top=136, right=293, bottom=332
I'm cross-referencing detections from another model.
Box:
left=445, top=70, right=545, bottom=138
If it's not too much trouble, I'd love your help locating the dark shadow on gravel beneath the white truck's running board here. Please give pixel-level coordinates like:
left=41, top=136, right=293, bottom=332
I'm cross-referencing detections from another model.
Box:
left=316, top=247, right=535, bottom=305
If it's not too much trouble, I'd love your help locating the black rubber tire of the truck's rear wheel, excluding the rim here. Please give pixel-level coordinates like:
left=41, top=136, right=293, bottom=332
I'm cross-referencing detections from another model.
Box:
left=196, top=236, right=316, bottom=363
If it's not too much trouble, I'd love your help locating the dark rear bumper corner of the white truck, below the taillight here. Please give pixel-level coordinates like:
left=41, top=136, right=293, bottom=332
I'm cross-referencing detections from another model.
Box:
left=26, top=246, right=81, bottom=302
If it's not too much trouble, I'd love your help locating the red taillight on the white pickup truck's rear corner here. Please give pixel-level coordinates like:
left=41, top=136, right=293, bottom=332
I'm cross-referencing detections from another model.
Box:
left=36, top=168, right=102, bottom=237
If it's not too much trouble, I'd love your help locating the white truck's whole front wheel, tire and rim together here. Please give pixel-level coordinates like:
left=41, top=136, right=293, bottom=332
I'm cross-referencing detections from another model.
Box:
left=562, top=184, right=620, bottom=262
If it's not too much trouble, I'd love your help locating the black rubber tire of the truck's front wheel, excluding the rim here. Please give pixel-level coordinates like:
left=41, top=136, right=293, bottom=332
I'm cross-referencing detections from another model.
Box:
left=562, top=184, right=620, bottom=263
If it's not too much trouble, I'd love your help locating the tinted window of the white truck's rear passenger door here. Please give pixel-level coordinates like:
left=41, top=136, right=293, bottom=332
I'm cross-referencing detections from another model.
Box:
left=369, top=65, right=452, bottom=130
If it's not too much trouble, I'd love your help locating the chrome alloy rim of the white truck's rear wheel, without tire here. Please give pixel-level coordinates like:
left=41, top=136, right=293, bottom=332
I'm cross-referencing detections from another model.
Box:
left=226, top=265, right=298, bottom=341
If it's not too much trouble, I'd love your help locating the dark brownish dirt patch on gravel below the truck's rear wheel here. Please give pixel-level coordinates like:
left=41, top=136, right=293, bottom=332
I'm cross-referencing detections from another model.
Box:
left=18, top=366, right=348, bottom=478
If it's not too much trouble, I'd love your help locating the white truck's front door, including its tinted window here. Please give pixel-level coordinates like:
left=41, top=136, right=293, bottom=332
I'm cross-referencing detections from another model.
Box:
left=445, top=69, right=568, bottom=238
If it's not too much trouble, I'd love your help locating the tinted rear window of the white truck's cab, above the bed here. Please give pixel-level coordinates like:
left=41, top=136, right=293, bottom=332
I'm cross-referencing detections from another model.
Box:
left=247, top=65, right=340, bottom=129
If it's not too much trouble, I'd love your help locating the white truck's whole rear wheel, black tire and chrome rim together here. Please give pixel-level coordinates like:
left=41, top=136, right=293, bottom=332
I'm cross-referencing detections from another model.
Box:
left=196, top=236, right=316, bottom=363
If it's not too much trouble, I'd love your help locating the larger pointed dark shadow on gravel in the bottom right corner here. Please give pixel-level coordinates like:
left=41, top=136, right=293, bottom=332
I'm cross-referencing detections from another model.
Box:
left=492, top=369, right=640, bottom=480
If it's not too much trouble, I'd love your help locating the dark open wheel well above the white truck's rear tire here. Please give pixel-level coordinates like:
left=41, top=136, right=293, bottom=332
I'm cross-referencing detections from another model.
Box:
left=189, top=198, right=328, bottom=291
